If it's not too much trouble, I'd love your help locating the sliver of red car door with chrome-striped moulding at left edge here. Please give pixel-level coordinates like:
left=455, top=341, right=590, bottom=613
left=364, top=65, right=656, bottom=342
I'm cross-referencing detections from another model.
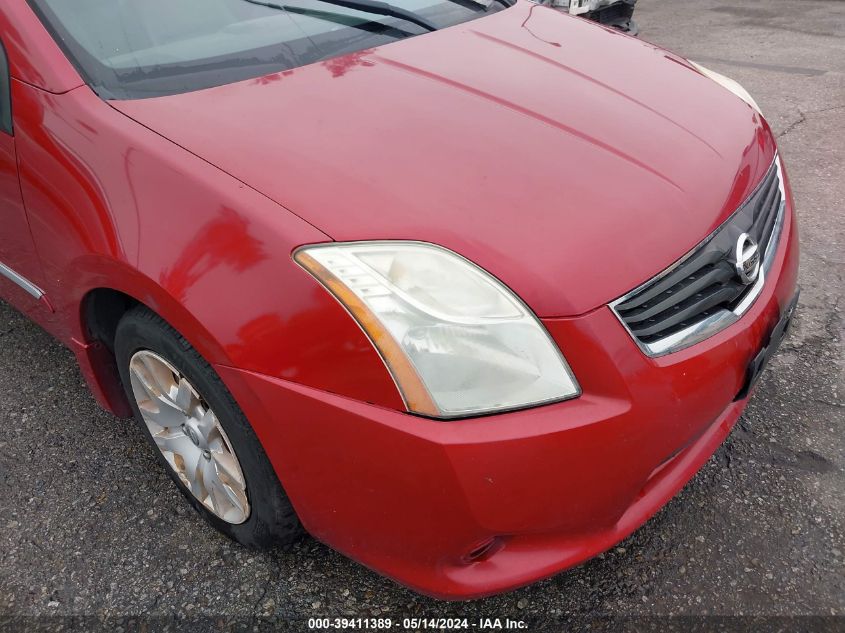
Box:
left=0, top=41, right=44, bottom=312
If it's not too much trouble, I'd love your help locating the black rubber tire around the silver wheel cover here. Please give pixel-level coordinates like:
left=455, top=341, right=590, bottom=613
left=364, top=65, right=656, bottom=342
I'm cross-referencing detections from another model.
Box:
left=114, top=306, right=303, bottom=547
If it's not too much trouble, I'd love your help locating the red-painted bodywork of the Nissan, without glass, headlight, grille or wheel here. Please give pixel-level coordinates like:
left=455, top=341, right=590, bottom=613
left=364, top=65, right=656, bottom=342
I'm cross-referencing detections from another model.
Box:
left=0, top=0, right=798, bottom=598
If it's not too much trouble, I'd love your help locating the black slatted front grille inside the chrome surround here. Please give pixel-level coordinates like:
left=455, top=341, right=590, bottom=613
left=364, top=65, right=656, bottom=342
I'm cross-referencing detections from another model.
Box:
left=613, top=160, right=783, bottom=345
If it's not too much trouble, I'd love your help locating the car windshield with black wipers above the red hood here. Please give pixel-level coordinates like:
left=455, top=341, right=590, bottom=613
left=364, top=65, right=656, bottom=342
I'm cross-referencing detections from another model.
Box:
left=29, top=0, right=510, bottom=99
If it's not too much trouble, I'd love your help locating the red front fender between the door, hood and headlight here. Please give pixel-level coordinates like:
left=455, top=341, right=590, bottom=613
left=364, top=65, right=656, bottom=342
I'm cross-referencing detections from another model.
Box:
left=14, top=83, right=402, bottom=408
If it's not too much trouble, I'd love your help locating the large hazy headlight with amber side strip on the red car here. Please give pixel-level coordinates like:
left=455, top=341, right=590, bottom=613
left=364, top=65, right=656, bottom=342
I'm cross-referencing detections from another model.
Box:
left=294, top=242, right=580, bottom=418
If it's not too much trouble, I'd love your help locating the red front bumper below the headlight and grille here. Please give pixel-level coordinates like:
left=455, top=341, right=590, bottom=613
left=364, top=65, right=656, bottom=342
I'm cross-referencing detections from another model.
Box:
left=217, top=194, right=798, bottom=599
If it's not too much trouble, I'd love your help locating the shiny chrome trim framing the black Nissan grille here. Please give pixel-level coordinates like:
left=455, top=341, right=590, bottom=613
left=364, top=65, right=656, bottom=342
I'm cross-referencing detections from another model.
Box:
left=610, top=155, right=786, bottom=357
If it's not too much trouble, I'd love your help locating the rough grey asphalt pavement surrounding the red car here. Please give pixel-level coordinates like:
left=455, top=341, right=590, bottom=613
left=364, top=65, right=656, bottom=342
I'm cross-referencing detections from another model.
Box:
left=0, top=0, right=845, bottom=627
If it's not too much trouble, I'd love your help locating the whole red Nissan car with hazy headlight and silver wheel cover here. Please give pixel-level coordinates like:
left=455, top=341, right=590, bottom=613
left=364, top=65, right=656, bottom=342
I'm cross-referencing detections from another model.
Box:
left=0, top=0, right=798, bottom=598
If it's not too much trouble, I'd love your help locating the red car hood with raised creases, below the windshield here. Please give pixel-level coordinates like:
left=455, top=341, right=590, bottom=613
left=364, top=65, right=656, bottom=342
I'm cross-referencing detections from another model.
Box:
left=110, top=1, right=775, bottom=317
